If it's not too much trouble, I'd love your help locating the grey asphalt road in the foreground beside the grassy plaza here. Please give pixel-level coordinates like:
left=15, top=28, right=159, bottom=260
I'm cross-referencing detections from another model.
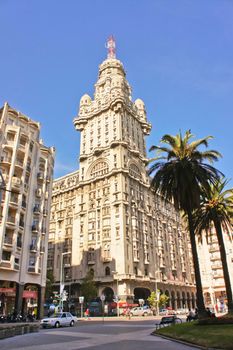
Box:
left=0, top=320, right=196, bottom=350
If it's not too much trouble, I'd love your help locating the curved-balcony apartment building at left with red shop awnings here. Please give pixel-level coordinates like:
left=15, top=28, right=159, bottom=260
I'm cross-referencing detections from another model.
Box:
left=0, top=103, right=54, bottom=317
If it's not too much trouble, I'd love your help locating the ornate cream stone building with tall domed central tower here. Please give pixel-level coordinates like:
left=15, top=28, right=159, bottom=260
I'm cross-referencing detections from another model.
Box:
left=48, top=41, right=195, bottom=308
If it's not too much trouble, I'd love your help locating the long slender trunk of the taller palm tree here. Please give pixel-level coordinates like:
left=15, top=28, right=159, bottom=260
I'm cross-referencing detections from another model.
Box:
left=187, top=210, right=207, bottom=318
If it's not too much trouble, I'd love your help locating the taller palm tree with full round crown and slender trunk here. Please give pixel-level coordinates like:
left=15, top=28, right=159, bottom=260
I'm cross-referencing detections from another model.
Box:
left=148, top=130, right=221, bottom=317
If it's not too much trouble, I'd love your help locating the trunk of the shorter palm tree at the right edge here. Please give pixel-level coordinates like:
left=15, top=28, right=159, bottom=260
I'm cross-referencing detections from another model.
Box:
left=214, top=220, right=233, bottom=314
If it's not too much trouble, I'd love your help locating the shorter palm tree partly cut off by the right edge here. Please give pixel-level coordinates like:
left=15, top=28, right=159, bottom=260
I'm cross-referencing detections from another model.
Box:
left=194, top=179, right=233, bottom=314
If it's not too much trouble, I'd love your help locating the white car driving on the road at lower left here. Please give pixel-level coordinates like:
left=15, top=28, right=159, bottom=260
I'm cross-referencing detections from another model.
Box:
left=40, top=312, right=77, bottom=328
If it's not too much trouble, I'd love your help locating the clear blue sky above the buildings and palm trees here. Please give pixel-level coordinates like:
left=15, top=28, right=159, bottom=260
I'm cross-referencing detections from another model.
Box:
left=0, top=0, right=233, bottom=185
